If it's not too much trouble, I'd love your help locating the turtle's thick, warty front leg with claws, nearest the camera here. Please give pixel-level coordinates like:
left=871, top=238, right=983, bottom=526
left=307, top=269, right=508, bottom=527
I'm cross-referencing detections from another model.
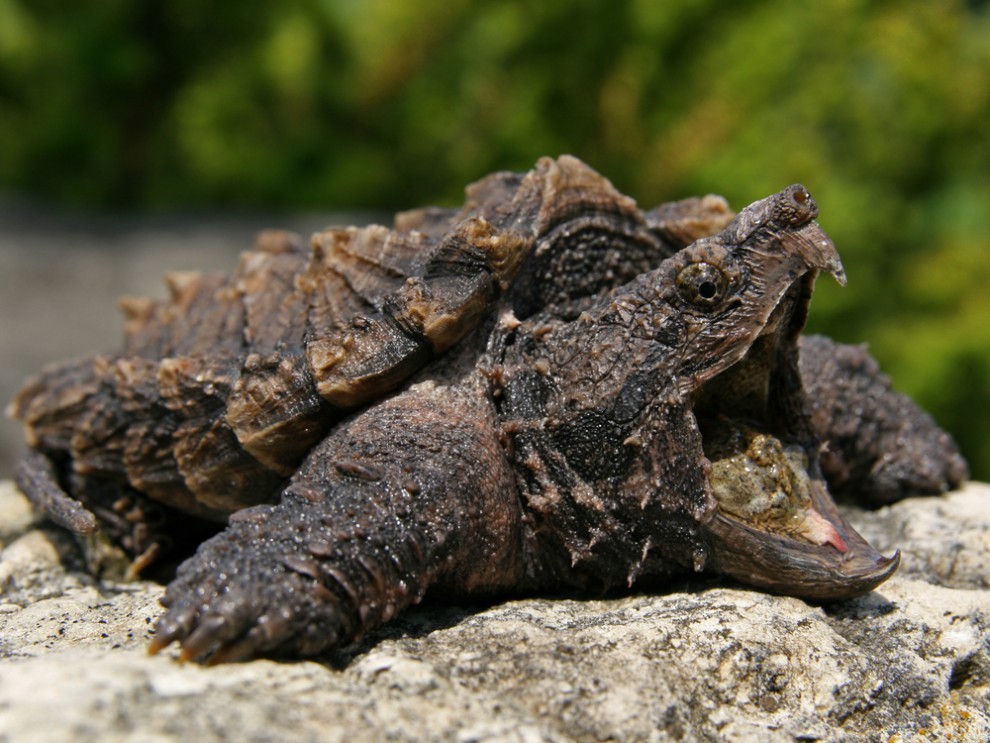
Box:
left=150, top=389, right=522, bottom=662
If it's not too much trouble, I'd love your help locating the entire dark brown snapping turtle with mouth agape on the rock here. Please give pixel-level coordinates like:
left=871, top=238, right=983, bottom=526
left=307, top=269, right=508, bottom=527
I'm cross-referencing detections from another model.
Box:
left=10, top=156, right=966, bottom=661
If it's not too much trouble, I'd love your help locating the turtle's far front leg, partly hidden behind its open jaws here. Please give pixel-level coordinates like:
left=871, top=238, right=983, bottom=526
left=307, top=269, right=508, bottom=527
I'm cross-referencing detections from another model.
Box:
left=801, top=336, right=969, bottom=506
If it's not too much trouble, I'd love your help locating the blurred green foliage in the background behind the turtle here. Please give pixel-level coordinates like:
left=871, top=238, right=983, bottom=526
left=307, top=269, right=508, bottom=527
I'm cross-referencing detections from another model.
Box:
left=0, top=0, right=990, bottom=479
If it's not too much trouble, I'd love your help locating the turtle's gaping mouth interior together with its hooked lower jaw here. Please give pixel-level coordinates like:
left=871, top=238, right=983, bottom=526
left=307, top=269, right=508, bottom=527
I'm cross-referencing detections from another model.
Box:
left=694, top=271, right=900, bottom=600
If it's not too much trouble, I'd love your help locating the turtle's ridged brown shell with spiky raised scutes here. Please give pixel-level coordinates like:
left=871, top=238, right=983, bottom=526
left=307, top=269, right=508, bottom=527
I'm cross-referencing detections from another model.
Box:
left=9, top=156, right=733, bottom=530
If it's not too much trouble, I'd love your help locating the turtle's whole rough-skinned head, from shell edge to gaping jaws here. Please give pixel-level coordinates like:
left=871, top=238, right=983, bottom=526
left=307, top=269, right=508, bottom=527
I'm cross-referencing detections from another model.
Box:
left=490, top=186, right=896, bottom=599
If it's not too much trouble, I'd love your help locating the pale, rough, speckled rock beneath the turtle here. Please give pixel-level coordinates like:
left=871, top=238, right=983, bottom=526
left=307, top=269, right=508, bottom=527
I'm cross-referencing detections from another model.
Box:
left=0, top=483, right=990, bottom=743
